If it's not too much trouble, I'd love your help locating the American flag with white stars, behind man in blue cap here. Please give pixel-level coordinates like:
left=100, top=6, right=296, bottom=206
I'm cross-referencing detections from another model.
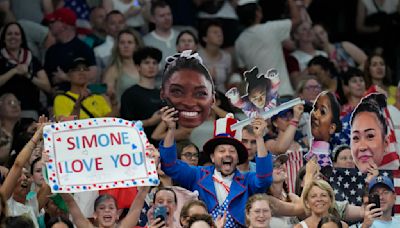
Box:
left=328, top=169, right=400, bottom=215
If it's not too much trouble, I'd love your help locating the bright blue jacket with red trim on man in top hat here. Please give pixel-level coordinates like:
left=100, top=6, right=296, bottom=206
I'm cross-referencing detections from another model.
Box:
left=159, top=142, right=273, bottom=225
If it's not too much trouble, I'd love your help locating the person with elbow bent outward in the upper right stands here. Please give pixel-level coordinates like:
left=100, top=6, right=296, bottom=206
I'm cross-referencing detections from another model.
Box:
left=313, top=24, right=367, bottom=72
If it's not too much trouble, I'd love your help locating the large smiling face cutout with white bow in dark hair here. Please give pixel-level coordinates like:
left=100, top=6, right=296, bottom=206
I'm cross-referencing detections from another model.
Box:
left=161, top=50, right=215, bottom=128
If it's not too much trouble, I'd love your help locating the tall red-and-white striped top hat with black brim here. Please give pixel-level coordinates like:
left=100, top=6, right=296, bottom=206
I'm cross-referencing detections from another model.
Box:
left=203, top=113, right=248, bottom=165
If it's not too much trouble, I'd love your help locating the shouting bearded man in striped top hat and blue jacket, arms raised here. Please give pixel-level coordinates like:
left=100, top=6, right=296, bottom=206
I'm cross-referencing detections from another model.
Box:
left=159, top=107, right=272, bottom=227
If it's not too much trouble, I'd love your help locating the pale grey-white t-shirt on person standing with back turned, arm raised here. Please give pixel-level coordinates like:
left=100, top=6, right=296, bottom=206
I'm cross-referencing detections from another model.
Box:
left=235, top=19, right=294, bottom=96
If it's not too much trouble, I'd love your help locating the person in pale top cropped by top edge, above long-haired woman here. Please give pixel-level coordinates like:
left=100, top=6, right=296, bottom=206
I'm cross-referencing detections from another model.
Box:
left=102, top=0, right=151, bottom=32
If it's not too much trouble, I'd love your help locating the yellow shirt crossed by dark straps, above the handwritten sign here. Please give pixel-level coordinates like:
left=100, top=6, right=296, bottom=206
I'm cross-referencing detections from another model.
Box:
left=54, top=91, right=111, bottom=119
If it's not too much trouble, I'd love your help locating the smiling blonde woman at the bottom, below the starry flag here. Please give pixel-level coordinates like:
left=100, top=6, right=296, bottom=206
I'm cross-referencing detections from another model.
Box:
left=294, top=180, right=348, bottom=228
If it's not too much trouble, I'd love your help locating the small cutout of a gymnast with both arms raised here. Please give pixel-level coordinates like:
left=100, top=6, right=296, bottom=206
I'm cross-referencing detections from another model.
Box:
left=225, top=67, right=280, bottom=117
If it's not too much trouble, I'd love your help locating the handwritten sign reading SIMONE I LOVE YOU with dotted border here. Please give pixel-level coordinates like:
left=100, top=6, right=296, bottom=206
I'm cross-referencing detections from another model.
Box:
left=43, top=118, right=159, bottom=192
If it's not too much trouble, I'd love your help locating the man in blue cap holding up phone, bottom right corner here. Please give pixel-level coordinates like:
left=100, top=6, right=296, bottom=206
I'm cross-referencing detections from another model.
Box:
left=362, top=176, right=400, bottom=228
